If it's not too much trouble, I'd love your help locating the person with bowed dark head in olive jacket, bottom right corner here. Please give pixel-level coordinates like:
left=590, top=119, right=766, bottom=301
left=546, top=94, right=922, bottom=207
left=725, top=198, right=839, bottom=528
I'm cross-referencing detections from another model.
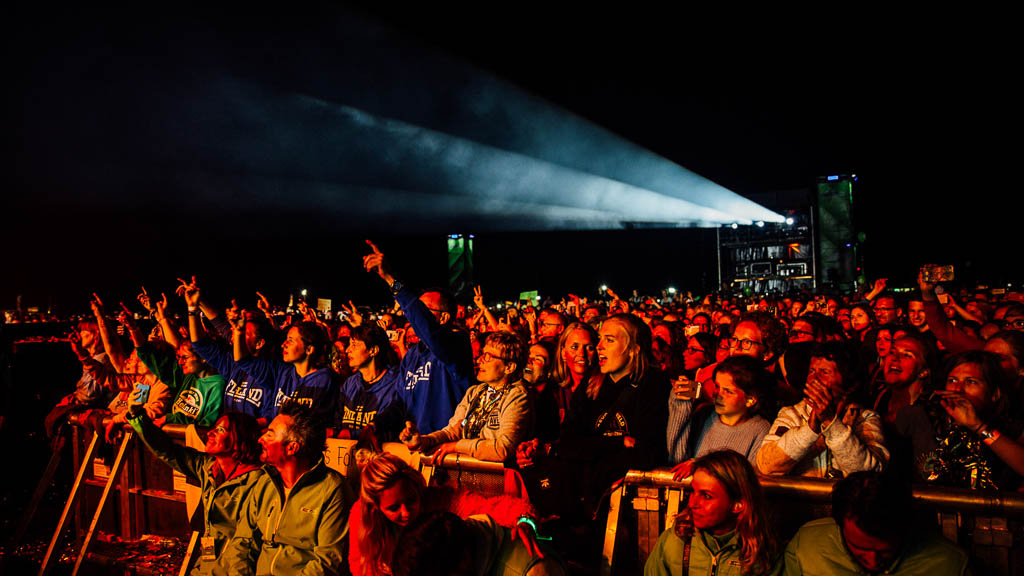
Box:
left=783, top=471, right=971, bottom=576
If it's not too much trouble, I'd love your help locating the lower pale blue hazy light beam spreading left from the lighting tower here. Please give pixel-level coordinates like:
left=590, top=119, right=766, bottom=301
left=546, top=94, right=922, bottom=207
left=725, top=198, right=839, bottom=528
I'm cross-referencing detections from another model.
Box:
left=136, top=75, right=761, bottom=230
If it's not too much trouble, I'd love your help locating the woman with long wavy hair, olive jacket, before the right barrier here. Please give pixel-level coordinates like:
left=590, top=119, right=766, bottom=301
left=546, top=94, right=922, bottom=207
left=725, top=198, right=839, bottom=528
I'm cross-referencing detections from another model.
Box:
left=644, top=450, right=782, bottom=576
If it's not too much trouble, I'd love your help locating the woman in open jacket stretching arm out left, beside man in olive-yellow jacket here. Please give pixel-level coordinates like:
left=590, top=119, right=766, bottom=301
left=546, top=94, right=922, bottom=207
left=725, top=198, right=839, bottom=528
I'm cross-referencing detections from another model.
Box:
left=128, top=405, right=263, bottom=576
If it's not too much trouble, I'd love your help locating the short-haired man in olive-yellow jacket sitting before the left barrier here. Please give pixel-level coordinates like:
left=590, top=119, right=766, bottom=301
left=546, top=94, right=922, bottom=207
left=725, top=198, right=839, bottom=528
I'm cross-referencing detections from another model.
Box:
left=223, top=402, right=353, bottom=576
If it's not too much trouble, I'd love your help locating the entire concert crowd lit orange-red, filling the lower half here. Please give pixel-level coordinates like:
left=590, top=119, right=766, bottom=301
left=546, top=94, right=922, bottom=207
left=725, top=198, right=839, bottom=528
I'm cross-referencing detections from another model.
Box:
left=34, top=244, right=1024, bottom=575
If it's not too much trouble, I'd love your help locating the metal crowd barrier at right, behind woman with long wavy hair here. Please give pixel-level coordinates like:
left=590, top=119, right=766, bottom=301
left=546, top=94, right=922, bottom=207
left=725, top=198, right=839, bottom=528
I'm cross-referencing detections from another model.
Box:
left=601, top=469, right=1024, bottom=576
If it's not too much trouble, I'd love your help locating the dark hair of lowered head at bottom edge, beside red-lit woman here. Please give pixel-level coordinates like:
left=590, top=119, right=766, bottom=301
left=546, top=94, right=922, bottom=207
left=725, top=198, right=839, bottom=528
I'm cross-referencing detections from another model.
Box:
left=391, top=511, right=474, bottom=576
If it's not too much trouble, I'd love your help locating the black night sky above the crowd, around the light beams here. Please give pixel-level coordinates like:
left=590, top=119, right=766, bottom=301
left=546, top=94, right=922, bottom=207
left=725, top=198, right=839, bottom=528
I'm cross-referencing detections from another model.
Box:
left=6, top=3, right=1022, bottom=312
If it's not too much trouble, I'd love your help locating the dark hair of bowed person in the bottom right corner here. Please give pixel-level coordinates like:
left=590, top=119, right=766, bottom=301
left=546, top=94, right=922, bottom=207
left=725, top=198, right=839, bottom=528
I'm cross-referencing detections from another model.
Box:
left=833, top=470, right=913, bottom=542
